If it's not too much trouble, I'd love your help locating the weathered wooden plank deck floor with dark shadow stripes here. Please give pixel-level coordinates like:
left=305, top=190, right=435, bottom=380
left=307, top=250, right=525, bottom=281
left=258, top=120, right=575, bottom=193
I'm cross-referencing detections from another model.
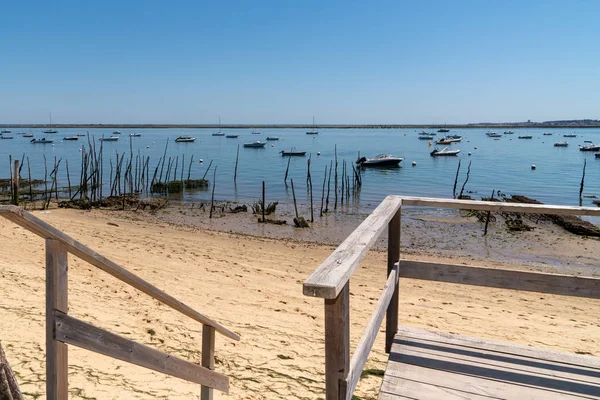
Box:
left=379, top=327, right=600, bottom=400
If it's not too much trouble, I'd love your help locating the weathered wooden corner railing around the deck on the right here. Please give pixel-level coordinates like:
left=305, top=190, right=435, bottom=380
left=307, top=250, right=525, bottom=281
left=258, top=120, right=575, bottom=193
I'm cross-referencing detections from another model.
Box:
left=303, top=196, right=600, bottom=400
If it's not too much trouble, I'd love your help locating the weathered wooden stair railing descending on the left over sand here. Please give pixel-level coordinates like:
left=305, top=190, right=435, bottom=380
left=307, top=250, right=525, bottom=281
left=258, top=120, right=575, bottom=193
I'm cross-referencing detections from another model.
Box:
left=0, top=206, right=240, bottom=400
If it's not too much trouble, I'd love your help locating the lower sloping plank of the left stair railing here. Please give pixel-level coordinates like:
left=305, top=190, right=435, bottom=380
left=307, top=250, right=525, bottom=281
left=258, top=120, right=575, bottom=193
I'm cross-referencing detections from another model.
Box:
left=55, top=311, right=229, bottom=392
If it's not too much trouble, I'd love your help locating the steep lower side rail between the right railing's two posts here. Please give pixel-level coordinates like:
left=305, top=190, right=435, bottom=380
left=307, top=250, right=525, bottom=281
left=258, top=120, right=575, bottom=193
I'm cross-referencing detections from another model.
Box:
left=345, top=265, right=398, bottom=400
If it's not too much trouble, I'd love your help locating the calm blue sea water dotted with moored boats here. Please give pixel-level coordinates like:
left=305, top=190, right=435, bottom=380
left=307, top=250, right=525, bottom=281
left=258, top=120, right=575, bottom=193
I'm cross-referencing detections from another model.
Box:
left=0, top=129, right=600, bottom=211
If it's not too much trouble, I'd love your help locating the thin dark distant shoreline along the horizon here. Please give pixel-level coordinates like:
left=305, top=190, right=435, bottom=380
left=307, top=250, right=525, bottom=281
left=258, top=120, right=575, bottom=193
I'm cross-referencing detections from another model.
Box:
left=0, top=121, right=600, bottom=129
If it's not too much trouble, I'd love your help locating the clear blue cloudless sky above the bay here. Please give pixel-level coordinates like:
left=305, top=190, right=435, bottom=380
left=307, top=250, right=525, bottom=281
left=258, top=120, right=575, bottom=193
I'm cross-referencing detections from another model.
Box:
left=0, top=0, right=600, bottom=124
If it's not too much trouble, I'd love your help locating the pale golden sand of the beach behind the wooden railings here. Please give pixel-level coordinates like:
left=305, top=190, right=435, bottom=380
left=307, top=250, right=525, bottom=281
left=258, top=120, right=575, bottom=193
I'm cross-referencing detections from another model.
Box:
left=0, top=210, right=600, bottom=399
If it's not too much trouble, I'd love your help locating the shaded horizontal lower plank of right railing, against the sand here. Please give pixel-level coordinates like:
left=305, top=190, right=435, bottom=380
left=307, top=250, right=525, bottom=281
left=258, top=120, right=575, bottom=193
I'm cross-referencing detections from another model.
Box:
left=400, top=260, right=600, bottom=299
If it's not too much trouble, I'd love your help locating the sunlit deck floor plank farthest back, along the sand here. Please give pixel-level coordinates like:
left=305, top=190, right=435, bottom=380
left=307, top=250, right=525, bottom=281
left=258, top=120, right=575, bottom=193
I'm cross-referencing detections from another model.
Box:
left=396, top=326, right=600, bottom=371
